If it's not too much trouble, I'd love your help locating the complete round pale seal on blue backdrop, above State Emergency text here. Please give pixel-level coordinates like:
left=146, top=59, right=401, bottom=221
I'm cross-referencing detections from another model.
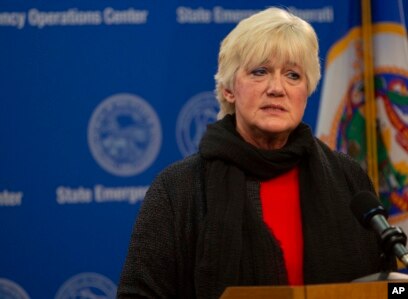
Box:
left=88, top=93, right=162, bottom=176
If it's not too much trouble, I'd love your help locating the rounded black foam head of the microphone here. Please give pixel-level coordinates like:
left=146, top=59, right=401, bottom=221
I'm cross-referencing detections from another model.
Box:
left=350, top=191, right=388, bottom=228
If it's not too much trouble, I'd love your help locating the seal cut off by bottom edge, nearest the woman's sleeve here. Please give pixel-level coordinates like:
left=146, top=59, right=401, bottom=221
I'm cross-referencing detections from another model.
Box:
left=55, top=273, right=116, bottom=299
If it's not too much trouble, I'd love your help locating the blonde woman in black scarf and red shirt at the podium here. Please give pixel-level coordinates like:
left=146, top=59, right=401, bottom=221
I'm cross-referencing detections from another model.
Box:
left=118, top=8, right=392, bottom=298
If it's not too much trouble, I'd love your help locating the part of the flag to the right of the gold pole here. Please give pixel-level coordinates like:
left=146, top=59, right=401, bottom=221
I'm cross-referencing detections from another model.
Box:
left=373, top=0, right=408, bottom=227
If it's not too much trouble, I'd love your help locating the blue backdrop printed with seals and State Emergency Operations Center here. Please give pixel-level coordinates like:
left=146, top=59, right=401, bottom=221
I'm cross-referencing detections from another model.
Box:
left=0, top=0, right=404, bottom=299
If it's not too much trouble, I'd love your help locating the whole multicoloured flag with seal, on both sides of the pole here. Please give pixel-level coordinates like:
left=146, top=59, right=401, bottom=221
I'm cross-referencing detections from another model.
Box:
left=316, top=0, right=408, bottom=227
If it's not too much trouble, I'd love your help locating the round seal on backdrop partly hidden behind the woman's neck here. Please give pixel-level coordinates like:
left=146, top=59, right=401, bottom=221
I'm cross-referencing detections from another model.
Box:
left=176, top=91, right=219, bottom=157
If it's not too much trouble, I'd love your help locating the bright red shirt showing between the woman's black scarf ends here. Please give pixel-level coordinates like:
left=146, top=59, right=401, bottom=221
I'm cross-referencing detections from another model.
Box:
left=260, top=168, right=303, bottom=285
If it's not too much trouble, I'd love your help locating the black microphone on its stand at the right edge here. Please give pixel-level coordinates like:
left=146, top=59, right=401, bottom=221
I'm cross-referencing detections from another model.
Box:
left=350, top=191, right=408, bottom=268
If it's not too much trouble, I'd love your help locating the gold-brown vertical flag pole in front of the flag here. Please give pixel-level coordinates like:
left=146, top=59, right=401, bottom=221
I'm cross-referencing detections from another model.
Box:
left=361, top=0, right=379, bottom=193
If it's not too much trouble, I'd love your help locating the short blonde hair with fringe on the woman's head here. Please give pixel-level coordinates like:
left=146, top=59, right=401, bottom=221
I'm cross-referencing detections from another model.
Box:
left=215, top=8, right=321, bottom=119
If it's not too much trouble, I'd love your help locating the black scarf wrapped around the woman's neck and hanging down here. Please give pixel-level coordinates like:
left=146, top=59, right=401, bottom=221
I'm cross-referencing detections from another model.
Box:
left=195, top=115, right=344, bottom=298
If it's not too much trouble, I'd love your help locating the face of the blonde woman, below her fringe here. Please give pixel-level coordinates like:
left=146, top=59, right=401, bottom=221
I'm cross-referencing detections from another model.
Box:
left=223, top=60, right=308, bottom=149
